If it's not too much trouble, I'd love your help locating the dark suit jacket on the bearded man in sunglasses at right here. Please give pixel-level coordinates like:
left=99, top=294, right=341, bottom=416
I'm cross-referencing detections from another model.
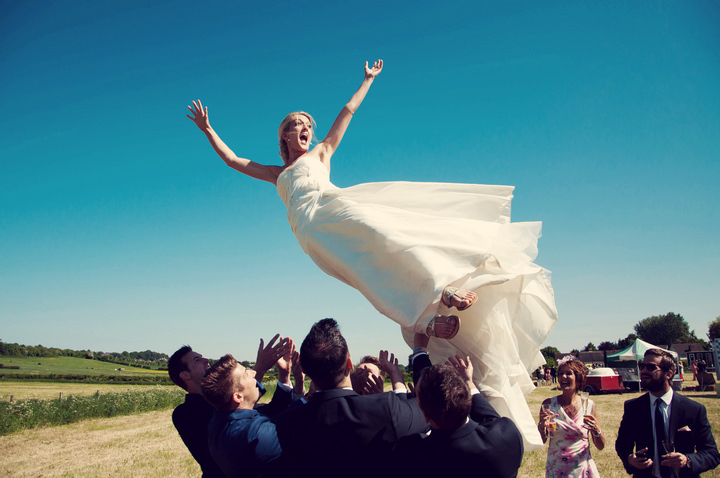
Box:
left=615, top=392, right=720, bottom=478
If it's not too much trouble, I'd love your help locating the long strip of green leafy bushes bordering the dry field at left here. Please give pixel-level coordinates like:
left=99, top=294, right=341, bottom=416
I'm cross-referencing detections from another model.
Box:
left=0, top=387, right=185, bottom=435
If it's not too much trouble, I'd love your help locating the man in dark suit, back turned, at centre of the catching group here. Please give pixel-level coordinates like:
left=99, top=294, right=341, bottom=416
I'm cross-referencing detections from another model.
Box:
left=275, top=319, right=427, bottom=478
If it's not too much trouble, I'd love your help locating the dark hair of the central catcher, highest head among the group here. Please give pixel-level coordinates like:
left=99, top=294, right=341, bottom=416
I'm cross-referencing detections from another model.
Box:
left=300, top=319, right=349, bottom=390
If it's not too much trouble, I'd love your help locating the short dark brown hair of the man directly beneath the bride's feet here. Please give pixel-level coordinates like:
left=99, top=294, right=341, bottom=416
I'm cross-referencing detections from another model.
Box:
left=415, top=363, right=472, bottom=429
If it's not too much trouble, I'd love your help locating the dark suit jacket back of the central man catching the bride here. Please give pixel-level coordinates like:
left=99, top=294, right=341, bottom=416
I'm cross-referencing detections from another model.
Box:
left=275, top=389, right=427, bottom=477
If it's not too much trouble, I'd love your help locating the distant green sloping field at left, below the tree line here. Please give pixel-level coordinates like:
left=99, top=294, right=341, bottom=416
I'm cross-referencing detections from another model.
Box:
left=0, top=357, right=167, bottom=375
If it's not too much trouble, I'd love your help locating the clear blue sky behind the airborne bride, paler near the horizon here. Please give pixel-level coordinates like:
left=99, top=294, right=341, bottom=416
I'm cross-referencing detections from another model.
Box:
left=0, top=0, right=720, bottom=359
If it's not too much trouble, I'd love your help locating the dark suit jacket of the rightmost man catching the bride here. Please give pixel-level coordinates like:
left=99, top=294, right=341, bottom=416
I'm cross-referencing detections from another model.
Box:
left=394, top=354, right=523, bottom=478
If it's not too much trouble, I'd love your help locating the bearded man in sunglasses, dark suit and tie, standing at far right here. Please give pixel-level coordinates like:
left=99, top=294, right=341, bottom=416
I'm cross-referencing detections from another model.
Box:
left=615, top=349, right=720, bottom=478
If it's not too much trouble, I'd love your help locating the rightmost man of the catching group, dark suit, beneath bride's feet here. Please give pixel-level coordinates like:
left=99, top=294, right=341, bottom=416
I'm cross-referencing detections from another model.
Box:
left=395, top=334, right=523, bottom=478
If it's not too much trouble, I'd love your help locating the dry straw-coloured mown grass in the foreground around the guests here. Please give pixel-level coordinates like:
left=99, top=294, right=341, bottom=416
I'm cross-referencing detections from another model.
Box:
left=0, top=382, right=720, bottom=478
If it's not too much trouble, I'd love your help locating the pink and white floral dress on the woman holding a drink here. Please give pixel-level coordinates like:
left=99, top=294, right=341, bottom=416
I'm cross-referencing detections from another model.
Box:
left=545, top=397, right=600, bottom=478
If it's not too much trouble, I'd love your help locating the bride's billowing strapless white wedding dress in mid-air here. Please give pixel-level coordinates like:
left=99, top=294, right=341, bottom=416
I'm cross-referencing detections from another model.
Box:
left=277, top=155, right=557, bottom=450
